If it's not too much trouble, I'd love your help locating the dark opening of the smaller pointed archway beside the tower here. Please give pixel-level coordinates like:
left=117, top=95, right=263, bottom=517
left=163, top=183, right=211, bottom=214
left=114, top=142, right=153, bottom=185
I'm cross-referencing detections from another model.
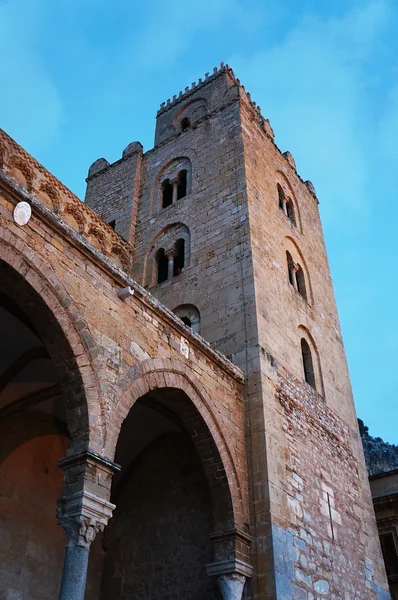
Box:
left=101, top=387, right=233, bottom=600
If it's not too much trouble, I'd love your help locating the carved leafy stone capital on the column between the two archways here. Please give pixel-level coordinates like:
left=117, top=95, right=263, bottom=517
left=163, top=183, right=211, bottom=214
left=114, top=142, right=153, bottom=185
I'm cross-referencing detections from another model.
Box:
left=57, top=490, right=115, bottom=548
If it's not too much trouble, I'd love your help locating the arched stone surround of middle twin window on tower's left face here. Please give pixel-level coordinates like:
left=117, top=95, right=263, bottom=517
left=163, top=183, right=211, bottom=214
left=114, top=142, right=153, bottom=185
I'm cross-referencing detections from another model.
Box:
left=143, top=223, right=191, bottom=287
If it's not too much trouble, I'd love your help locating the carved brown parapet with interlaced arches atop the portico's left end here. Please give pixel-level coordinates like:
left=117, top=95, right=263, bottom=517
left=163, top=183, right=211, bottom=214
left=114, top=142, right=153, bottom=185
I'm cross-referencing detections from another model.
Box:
left=0, top=129, right=132, bottom=271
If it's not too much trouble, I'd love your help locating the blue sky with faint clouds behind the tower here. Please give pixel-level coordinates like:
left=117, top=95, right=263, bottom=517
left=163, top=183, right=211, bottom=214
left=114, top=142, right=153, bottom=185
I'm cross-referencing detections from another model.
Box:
left=0, top=0, right=398, bottom=443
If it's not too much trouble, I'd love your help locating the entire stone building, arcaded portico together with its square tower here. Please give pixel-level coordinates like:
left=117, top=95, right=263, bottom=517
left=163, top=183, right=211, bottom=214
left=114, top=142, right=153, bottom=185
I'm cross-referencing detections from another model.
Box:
left=0, top=65, right=390, bottom=600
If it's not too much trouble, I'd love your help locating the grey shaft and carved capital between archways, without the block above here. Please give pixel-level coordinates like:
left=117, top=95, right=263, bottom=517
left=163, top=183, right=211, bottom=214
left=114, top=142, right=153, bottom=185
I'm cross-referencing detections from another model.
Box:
left=57, top=491, right=115, bottom=600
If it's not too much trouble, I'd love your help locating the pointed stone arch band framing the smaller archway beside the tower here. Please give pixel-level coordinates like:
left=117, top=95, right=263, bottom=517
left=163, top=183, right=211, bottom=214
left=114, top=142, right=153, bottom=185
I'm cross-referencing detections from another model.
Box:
left=105, top=359, right=245, bottom=530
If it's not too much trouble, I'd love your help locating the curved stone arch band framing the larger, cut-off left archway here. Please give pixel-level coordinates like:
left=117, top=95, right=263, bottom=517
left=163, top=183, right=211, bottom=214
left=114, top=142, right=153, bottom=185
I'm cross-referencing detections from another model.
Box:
left=0, top=240, right=101, bottom=454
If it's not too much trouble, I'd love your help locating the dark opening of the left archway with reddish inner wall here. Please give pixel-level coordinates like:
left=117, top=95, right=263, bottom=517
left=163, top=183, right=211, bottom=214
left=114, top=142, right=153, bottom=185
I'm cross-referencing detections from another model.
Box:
left=0, top=261, right=95, bottom=600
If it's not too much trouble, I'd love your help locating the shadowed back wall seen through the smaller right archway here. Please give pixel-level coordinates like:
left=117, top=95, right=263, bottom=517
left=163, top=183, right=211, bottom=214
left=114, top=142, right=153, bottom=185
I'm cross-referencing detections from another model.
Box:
left=101, top=433, right=218, bottom=600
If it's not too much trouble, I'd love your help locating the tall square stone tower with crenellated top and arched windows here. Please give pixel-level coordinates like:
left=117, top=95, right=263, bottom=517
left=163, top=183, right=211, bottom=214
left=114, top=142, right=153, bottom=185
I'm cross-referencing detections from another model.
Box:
left=86, top=65, right=389, bottom=600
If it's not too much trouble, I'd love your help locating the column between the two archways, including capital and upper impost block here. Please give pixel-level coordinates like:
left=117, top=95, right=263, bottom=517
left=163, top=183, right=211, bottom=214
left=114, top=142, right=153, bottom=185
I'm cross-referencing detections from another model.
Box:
left=57, top=451, right=118, bottom=600
